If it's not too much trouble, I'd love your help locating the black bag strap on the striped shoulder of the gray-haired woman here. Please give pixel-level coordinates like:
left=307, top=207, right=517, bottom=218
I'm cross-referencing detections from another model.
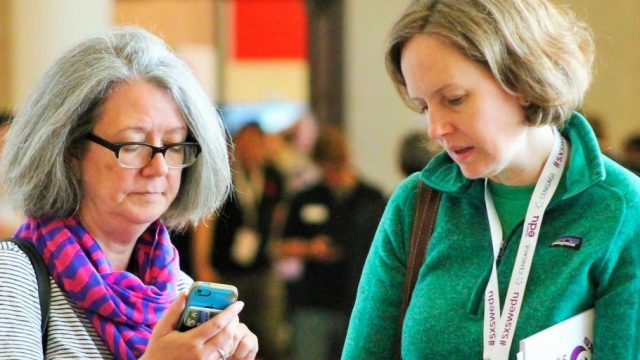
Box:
left=7, top=238, right=51, bottom=353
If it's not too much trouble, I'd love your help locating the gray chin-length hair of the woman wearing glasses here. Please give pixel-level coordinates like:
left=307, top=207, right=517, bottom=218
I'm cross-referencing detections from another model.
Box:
left=1, top=27, right=231, bottom=227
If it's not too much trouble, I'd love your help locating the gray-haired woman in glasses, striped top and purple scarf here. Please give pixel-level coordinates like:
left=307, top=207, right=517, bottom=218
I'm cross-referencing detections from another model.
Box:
left=0, top=27, right=258, bottom=359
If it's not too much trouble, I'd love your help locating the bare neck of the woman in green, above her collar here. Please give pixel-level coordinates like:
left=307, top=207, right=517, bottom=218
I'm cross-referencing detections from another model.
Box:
left=490, top=126, right=554, bottom=186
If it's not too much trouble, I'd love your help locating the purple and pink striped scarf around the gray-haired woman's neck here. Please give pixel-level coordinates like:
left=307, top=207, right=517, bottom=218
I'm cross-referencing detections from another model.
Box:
left=15, top=217, right=180, bottom=359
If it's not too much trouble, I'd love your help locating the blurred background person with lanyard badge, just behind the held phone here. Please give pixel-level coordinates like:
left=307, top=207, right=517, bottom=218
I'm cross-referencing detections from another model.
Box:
left=193, top=122, right=284, bottom=360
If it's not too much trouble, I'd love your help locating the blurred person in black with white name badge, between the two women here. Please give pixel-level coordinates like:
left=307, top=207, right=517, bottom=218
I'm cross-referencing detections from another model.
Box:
left=276, top=125, right=386, bottom=360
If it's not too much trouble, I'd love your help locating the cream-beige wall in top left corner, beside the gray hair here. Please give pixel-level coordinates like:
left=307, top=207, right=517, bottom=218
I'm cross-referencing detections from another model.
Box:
left=0, top=0, right=111, bottom=111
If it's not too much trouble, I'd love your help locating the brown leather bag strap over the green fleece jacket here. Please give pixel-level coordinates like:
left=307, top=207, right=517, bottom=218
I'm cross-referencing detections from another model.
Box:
left=396, top=181, right=441, bottom=359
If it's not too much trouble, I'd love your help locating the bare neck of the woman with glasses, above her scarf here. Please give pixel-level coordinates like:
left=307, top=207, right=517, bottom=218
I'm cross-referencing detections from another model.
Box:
left=80, top=213, right=149, bottom=271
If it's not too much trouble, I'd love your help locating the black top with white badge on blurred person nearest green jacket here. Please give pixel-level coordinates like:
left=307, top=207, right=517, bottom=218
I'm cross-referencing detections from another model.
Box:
left=283, top=182, right=386, bottom=314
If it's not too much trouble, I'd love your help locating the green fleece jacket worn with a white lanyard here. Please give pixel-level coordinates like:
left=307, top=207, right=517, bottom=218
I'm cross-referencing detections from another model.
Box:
left=342, top=113, right=640, bottom=360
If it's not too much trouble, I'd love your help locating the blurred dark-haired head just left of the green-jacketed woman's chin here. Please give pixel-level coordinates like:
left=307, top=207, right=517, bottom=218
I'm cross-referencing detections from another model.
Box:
left=398, top=130, right=434, bottom=177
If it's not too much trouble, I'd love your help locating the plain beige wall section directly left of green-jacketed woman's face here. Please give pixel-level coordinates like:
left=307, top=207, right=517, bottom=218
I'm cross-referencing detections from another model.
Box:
left=345, top=0, right=416, bottom=192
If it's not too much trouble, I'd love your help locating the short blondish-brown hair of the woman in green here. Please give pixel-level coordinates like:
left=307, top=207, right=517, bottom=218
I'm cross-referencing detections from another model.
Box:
left=386, top=0, right=594, bottom=126
